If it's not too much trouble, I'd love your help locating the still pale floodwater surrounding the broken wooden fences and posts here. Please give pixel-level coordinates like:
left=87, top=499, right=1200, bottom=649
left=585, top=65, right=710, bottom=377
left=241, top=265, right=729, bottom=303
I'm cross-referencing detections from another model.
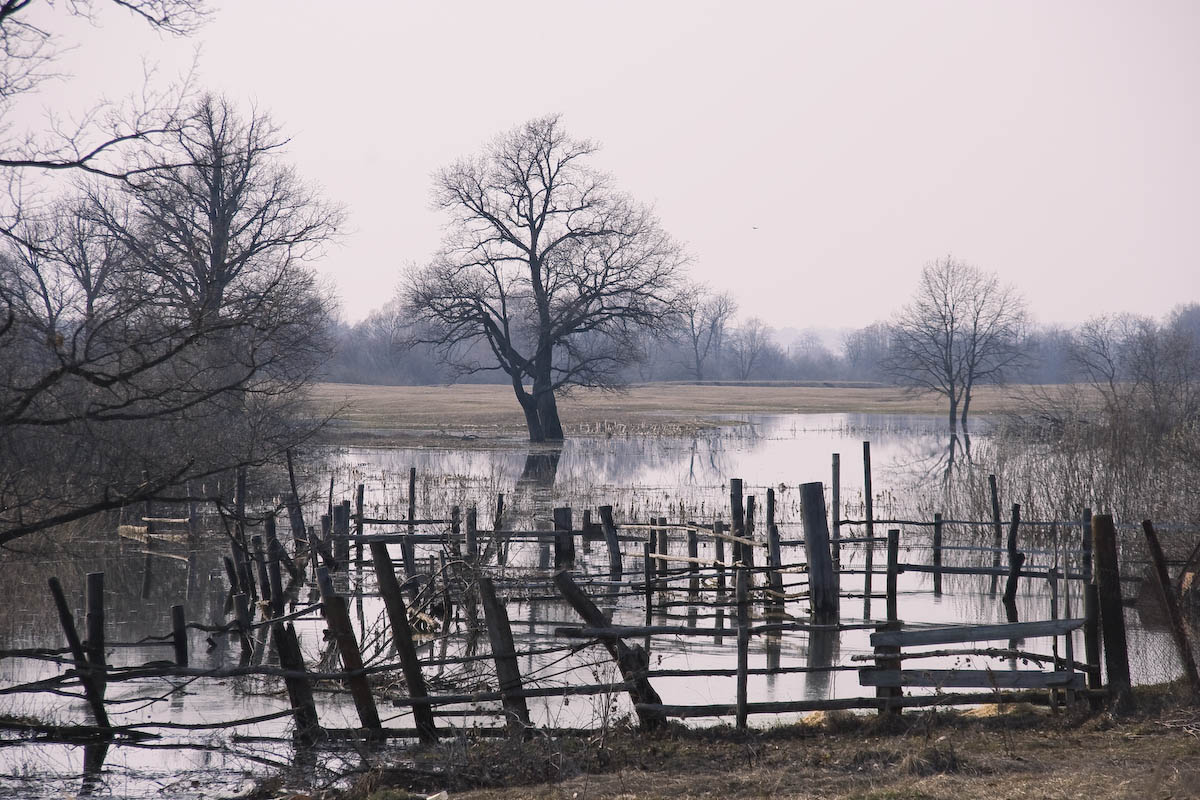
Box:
left=0, top=414, right=1178, bottom=798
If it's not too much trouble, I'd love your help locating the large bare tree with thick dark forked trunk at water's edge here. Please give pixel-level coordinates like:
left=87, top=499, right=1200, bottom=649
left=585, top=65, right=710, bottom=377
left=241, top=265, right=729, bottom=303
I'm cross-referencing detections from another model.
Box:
left=401, top=116, right=683, bottom=441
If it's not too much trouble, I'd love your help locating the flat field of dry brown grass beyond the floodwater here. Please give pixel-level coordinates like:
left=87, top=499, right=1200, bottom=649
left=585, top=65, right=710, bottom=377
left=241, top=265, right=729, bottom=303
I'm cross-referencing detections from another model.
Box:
left=311, top=384, right=1041, bottom=445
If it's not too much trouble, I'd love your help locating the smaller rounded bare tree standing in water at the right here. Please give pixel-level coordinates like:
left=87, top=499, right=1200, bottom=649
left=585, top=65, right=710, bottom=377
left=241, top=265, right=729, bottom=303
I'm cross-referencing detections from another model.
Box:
left=886, top=257, right=1026, bottom=434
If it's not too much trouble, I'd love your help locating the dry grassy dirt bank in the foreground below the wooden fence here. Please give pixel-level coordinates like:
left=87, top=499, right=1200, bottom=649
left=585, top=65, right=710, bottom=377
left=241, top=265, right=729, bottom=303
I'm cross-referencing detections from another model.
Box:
left=312, top=706, right=1200, bottom=800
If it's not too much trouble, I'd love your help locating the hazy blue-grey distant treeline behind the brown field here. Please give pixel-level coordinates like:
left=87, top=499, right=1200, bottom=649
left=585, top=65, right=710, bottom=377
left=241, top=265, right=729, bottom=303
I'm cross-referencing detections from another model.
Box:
left=325, top=303, right=1200, bottom=385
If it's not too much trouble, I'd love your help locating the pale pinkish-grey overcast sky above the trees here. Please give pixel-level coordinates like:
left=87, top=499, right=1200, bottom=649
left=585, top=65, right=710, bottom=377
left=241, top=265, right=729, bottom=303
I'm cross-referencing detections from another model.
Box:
left=23, top=0, right=1200, bottom=327
